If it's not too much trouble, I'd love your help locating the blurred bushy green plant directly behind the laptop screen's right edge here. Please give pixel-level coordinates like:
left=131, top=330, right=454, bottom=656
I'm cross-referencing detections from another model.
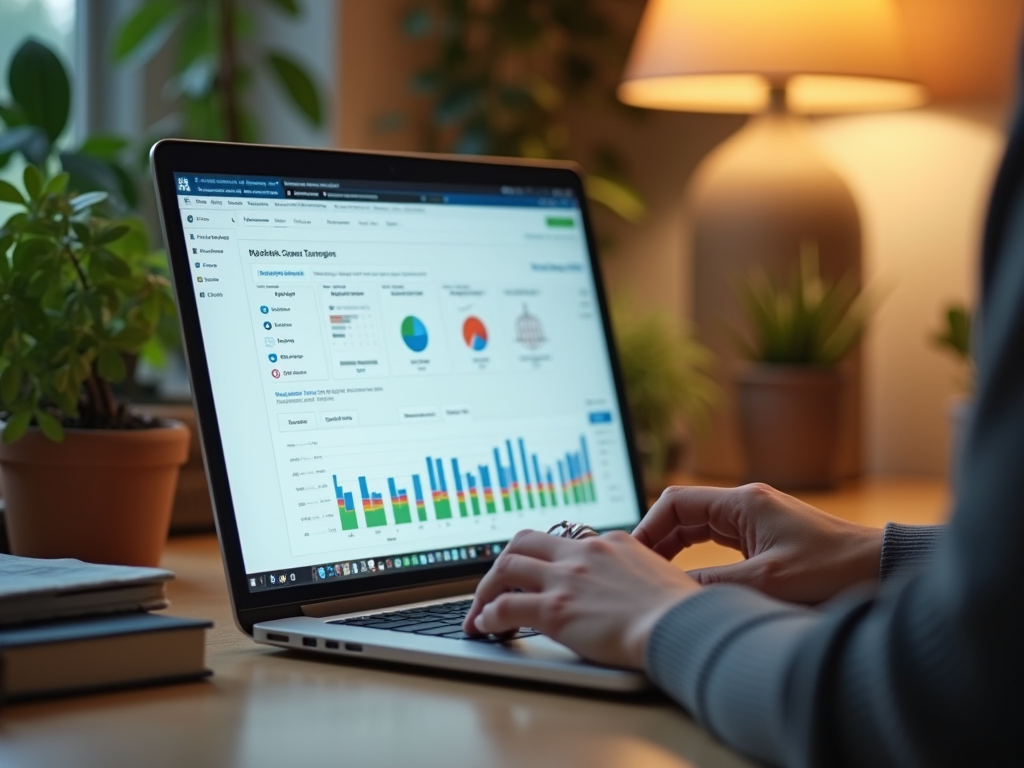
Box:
left=612, top=301, right=719, bottom=496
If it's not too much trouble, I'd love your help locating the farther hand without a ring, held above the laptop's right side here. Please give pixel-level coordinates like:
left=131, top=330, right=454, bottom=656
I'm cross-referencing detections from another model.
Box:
left=633, top=483, right=883, bottom=604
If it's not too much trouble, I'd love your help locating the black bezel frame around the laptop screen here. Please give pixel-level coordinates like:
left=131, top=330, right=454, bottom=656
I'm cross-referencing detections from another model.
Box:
left=150, top=139, right=647, bottom=632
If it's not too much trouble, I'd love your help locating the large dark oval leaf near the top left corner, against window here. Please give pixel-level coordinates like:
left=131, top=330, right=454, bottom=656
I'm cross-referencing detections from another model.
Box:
left=7, top=39, right=71, bottom=142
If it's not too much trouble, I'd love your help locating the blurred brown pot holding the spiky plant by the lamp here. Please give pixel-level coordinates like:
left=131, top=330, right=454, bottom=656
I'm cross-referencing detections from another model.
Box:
left=736, top=365, right=843, bottom=489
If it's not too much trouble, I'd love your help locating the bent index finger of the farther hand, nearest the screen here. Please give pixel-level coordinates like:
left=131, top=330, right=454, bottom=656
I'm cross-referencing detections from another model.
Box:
left=633, top=485, right=741, bottom=552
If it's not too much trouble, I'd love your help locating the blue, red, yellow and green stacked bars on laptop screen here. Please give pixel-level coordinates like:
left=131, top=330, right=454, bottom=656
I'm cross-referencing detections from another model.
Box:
left=334, top=435, right=597, bottom=530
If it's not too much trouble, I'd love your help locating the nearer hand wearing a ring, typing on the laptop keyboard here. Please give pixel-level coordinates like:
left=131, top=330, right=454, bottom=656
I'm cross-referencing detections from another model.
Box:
left=463, top=530, right=700, bottom=670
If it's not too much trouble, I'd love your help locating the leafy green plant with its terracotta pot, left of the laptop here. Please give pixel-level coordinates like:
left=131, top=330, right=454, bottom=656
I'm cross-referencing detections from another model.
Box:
left=0, top=165, right=188, bottom=564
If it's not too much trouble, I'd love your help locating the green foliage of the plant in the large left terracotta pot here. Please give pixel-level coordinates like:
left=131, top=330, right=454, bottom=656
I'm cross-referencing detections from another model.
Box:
left=0, top=165, right=174, bottom=442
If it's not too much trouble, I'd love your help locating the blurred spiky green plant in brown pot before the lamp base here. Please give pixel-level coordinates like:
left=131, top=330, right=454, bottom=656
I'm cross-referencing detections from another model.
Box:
left=736, top=243, right=867, bottom=489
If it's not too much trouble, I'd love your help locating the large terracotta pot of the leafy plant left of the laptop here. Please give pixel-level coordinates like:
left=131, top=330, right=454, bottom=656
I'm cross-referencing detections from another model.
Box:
left=0, top=422, right=189, bottom=565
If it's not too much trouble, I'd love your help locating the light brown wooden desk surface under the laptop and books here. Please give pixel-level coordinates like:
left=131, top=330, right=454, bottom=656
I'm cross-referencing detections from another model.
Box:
left=0, top=480, right=946, bottom=768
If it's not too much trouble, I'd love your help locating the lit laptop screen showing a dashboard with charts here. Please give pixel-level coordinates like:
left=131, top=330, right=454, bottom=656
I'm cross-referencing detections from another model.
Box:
left=175, top=173, right=641, bottom=592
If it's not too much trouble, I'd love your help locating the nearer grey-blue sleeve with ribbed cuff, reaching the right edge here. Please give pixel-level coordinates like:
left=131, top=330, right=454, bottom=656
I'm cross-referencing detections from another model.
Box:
left=646, top=66, right=1024, bottom=768
